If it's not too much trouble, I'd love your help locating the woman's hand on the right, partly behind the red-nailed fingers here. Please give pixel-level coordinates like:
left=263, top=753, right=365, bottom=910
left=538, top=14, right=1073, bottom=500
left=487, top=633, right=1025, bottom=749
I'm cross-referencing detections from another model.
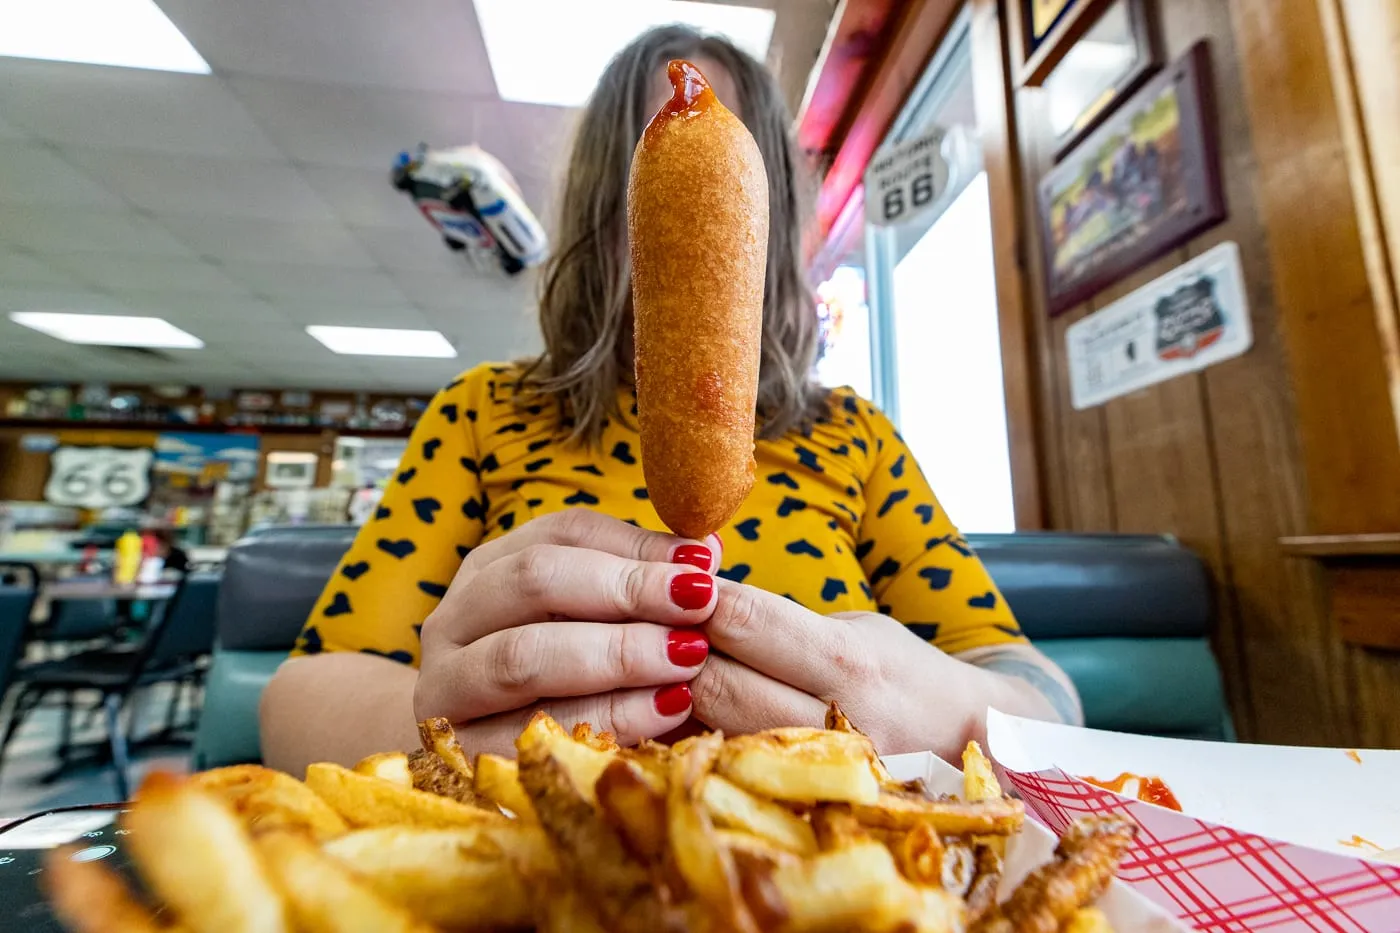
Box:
left=692, top=580, right=1069, bottom=756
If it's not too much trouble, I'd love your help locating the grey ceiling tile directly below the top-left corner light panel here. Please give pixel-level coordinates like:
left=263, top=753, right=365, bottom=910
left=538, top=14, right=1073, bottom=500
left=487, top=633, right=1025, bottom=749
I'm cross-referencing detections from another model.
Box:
left=0, top=59, right=279, bottom=158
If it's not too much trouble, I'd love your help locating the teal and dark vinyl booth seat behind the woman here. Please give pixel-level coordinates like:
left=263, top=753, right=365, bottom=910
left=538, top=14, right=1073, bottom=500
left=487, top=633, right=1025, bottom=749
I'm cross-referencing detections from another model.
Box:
left=195, top=525, right=1233, bottom=768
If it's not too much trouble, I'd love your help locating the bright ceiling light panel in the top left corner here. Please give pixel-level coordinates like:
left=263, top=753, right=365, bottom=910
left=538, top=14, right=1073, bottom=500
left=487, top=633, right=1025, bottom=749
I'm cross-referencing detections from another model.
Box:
left=0, top=0, right=209, bottom=74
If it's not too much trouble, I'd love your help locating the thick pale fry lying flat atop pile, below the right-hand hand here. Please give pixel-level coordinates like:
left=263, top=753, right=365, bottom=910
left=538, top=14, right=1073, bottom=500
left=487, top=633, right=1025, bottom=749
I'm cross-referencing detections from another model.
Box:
left=717, top=727, right=879, bottom=804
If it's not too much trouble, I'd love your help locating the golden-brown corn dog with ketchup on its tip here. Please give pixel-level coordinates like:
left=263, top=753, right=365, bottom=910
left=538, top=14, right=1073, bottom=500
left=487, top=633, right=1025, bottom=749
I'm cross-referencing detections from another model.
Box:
left=627, top=60, right=769, bottom=538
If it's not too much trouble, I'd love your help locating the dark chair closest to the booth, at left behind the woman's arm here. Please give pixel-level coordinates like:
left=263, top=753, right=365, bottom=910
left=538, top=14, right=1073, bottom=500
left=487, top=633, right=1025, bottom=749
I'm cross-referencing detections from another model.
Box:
left=0, top=572, right=220, bottom=800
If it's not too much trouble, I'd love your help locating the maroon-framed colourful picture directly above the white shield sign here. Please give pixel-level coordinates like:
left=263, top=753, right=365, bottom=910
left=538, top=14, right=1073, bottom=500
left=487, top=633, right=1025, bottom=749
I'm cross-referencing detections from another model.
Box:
left=1036, top=41, right=1225, bottom=314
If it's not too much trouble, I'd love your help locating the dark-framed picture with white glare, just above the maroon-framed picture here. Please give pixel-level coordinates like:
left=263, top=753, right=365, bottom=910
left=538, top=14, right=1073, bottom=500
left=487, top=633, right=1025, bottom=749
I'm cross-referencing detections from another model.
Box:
left=1040, top=0, right=1162, bottom=161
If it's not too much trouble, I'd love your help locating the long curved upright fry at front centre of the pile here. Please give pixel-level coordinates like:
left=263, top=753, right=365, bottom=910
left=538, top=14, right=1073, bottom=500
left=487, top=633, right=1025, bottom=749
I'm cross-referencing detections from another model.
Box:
left=666, top=733, right=759, bottom=933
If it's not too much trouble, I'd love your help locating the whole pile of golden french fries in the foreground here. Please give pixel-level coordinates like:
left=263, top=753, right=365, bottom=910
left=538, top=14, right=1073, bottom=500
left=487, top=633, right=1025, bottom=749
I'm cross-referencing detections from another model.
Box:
left=45, top=705, right=1135, bottom=933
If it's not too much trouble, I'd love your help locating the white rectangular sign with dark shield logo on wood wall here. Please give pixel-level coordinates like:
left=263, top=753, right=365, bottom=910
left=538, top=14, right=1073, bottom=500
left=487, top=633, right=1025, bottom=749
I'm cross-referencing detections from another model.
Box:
left=1064, top=242, right=1254, bottom=410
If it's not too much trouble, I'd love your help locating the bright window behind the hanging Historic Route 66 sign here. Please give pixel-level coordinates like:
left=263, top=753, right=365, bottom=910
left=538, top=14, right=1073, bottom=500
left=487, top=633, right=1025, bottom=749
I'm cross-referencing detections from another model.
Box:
left=865, top=10, right=1015, bottom=531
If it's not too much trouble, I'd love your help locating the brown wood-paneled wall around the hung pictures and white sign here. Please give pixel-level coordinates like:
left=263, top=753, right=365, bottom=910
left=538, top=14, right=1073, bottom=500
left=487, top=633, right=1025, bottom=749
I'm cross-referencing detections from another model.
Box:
left=1001, top=0, right=1400, bottom=748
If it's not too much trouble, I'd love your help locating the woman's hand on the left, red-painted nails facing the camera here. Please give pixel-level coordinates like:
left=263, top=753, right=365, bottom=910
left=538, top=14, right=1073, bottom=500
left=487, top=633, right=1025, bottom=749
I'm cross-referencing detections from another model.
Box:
left=413, top=509, right=720, bottom=751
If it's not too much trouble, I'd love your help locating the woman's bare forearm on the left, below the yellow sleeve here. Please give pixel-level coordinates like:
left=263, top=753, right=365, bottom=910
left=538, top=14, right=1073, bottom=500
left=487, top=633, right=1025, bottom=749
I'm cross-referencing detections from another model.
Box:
left=259, top=651, right=419, bottom=778
